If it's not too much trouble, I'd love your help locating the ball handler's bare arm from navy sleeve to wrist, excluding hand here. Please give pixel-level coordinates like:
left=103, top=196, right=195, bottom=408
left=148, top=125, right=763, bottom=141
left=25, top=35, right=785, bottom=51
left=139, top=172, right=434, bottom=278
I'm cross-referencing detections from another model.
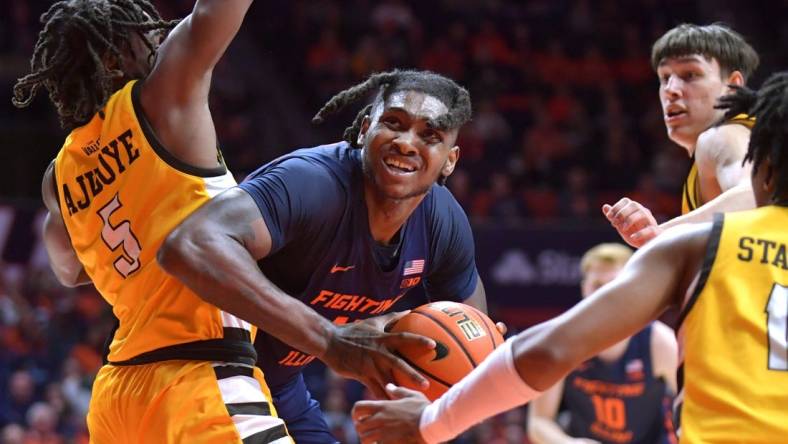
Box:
left=158, top=188, right=333, bottom=359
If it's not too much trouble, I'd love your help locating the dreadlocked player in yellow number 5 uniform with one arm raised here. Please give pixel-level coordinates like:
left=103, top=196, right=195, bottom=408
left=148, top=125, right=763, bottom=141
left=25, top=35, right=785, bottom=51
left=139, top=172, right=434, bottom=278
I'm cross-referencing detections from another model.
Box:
left=14, top=0, right=292, bottom=443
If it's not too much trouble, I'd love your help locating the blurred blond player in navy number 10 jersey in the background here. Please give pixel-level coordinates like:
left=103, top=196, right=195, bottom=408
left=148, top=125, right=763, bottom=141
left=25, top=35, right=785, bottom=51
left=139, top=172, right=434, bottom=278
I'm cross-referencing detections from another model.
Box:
left=528, top=244, right=678, bottom=444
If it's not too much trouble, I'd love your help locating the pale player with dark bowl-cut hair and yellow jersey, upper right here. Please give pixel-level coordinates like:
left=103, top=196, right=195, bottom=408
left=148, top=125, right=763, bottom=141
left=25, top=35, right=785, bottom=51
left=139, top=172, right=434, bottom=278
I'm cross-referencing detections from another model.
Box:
left=602, top=24, right=758, bottom=248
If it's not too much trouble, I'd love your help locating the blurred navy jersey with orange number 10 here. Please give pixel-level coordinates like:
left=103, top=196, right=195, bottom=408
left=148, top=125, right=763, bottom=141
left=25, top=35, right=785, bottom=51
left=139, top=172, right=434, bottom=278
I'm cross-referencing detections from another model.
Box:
left=563, top=326, right=673, bottom=444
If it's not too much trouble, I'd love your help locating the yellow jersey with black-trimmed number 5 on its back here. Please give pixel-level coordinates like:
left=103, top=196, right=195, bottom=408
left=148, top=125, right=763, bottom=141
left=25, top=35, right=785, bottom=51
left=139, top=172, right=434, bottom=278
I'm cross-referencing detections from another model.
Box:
left=55, top=81, right=255, bottom=364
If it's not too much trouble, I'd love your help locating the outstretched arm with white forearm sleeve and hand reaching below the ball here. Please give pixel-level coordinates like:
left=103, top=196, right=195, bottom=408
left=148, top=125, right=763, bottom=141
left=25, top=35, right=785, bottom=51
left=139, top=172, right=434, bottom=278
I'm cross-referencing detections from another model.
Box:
left=353, top=224, right=711, bottom=444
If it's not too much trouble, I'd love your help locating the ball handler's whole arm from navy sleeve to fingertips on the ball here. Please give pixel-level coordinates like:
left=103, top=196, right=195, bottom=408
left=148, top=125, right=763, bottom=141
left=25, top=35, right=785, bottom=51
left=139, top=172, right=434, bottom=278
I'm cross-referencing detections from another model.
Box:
left=158, top=188, right=435, bottom=398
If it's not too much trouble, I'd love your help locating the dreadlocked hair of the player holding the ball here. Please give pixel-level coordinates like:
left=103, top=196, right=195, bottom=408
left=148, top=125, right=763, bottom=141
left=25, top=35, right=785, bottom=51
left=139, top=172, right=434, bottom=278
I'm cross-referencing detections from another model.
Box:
left=312, top=70, right=471, bottom=148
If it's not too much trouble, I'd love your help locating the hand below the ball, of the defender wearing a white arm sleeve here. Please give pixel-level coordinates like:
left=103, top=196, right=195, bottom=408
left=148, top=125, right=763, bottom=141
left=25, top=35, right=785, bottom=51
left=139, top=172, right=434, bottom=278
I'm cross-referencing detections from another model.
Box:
left=352, top=384, right=429, bottom=444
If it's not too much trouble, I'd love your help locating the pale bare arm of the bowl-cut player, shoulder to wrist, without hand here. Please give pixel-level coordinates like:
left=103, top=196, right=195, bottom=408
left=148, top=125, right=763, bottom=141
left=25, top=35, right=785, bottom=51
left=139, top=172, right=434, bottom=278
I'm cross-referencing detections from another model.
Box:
left=660, top=125, right=755, bottom=229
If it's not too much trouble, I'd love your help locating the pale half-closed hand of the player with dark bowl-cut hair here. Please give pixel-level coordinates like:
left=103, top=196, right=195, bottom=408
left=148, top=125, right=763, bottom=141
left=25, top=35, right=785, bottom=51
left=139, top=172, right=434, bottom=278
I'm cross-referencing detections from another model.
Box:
left=602, top=197, right=662, bottom=248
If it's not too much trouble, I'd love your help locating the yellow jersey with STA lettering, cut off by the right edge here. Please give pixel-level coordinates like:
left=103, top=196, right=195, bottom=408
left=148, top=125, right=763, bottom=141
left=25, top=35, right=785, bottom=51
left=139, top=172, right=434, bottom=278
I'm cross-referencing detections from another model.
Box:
left=676, top=206, right=788, bottom=444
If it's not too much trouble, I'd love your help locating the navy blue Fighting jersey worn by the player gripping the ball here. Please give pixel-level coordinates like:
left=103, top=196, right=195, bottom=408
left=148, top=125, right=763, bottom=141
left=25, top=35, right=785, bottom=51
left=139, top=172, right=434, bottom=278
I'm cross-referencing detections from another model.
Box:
left=239, top=142, right=478, bottom=387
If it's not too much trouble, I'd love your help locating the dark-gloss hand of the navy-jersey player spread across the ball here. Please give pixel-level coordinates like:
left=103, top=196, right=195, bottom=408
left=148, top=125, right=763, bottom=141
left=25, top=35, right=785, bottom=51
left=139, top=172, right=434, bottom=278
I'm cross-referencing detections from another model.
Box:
left=322, top=312, right=435, bottom=399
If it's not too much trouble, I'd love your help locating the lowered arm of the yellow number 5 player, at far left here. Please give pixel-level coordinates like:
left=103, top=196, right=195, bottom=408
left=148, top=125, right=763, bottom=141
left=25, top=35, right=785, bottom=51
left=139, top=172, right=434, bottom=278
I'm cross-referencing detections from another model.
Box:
left=41, top=161, right=90, bottom=287
